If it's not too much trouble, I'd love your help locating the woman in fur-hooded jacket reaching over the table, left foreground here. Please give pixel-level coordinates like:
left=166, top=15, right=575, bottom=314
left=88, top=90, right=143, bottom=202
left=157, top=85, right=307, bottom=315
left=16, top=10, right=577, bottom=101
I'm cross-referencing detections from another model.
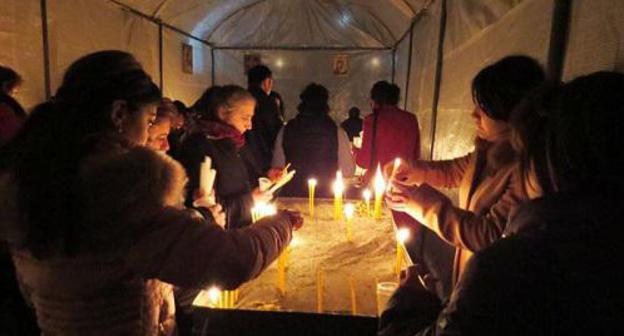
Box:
left=0, top=51, right=301, bottom=335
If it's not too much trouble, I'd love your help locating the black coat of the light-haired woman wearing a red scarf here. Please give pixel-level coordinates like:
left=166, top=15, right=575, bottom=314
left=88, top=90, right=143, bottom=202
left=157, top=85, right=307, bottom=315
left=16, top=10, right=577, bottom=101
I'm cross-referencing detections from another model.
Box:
left=176, top=133, right=262, bottom=229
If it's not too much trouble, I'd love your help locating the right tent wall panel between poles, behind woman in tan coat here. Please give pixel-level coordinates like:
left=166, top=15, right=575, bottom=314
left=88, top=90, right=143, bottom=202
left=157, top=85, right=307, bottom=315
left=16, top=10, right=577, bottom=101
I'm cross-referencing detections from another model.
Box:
left=434, top=0, right=554, bottom=159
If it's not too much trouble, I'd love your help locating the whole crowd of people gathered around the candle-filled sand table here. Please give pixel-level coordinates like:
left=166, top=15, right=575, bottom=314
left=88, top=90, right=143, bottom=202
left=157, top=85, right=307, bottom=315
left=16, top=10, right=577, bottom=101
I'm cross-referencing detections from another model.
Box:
left=0, top=51, right=624, bottom=335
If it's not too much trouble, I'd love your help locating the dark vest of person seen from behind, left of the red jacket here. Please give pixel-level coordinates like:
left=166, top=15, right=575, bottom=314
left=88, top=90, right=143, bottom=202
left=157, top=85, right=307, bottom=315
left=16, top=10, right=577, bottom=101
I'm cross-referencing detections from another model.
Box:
left=282, top=112, right=338, bottom=197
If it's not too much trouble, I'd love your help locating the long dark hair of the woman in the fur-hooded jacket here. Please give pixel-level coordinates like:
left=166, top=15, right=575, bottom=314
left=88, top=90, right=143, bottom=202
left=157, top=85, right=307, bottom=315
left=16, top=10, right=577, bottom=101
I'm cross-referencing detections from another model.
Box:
left=0, top=51, right=161, bottom=258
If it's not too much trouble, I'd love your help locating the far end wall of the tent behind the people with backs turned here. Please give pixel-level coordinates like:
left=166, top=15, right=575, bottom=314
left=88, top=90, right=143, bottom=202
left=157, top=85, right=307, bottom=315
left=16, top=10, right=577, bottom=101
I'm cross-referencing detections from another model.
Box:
left=215, top=49, right=392, bottom=121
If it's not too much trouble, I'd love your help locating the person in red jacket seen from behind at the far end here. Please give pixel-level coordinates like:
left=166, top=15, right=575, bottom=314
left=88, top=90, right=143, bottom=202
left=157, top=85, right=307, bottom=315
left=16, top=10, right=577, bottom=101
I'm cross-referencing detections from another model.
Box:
left=354, top=81, right=420, bottom=184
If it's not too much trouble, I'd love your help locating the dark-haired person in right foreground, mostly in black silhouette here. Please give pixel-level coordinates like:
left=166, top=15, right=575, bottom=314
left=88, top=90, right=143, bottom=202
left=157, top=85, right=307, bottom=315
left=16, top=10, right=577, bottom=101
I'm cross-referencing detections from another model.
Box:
left=379, top=72, right=624, bottom=336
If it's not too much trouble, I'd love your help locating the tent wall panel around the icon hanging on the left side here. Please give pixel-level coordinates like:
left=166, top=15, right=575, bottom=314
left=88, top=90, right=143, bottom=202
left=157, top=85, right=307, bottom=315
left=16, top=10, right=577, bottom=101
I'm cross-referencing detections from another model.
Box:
left=163, top=29, right=212, bottom=106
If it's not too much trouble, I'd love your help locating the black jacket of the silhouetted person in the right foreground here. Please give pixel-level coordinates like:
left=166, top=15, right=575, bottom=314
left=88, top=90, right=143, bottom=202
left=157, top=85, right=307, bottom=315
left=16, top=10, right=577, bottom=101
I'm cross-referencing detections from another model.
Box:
left=380, top=195, right=624, bottom=335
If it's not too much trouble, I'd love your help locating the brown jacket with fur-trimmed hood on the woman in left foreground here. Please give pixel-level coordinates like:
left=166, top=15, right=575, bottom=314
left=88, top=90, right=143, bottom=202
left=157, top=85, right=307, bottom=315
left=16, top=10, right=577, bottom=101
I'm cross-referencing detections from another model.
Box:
left=0, top=134, right=292, bottom=335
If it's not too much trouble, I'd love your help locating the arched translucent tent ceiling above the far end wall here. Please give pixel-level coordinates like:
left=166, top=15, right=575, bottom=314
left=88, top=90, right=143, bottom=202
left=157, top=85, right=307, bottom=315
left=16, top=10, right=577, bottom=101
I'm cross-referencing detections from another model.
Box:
left=114, top=0, right=431, bottom=48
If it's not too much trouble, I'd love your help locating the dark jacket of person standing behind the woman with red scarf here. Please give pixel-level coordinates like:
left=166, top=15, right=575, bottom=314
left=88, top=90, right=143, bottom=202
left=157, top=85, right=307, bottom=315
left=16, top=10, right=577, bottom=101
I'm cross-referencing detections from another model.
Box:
left=246, top=87, right=282, bottom=171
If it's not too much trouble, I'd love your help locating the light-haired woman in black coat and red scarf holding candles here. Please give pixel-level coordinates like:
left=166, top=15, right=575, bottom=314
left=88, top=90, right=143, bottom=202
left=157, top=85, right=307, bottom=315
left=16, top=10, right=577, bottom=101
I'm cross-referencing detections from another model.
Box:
left=177, top=85, right=279, bottom=229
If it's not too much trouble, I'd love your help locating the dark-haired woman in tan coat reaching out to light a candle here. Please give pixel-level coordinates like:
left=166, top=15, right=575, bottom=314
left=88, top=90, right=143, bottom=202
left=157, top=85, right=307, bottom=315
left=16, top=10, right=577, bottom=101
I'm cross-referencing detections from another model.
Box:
left=386, top=56, right=544, bottom=283
